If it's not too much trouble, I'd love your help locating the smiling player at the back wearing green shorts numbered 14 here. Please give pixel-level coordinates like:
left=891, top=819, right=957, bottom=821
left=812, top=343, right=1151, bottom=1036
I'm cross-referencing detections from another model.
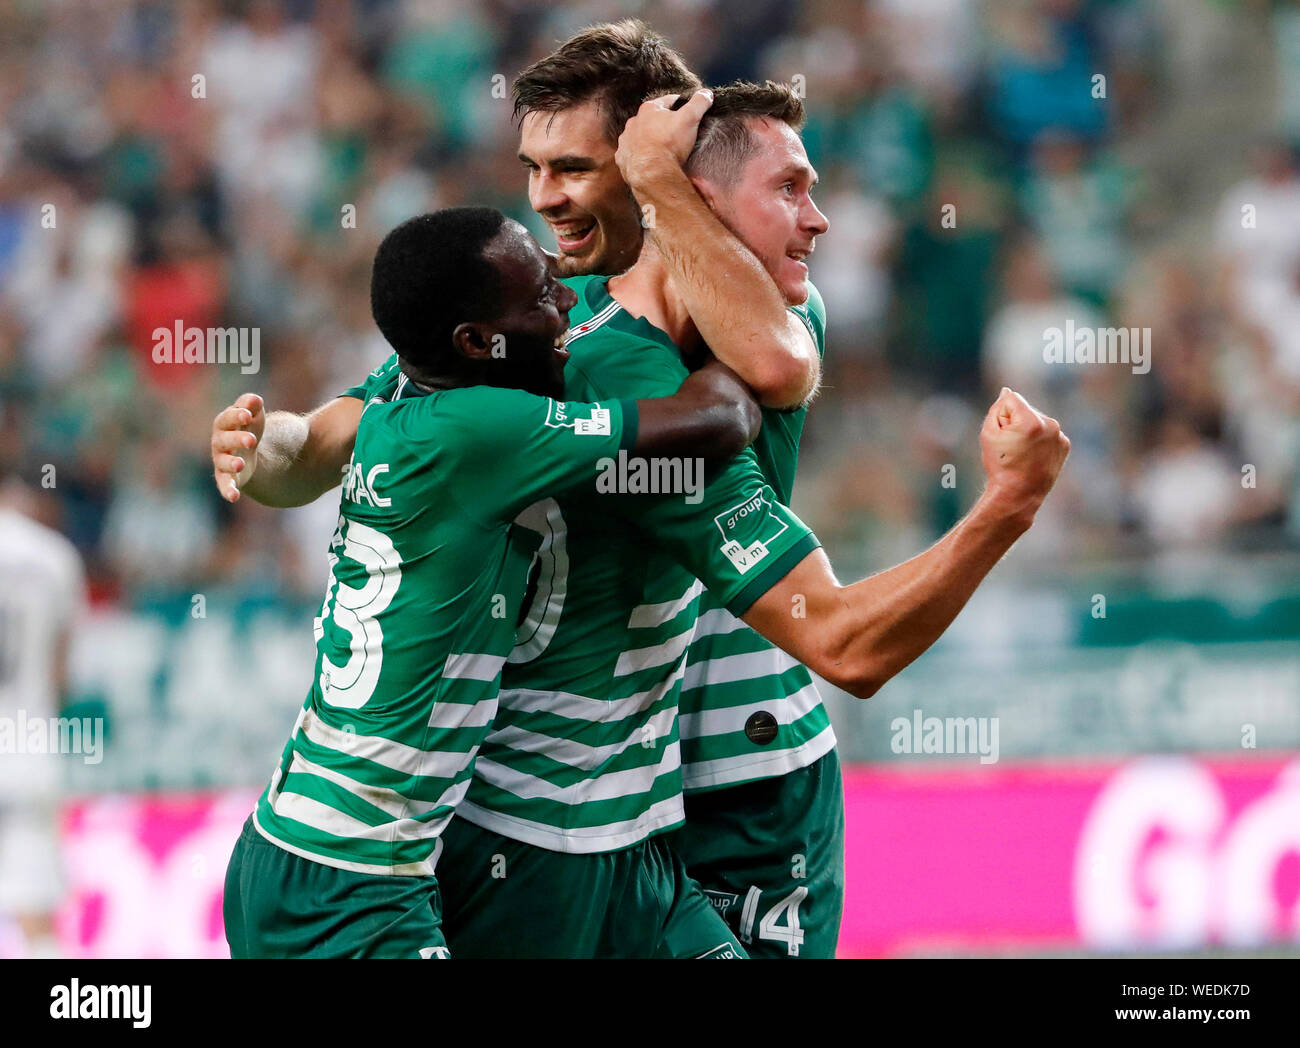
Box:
left=213, top=22, right=844, bottom=957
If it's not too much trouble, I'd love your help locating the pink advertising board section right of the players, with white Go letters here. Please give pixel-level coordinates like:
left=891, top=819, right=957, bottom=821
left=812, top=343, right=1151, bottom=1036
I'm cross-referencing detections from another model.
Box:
left=840, top=757, right=1300, bottom=957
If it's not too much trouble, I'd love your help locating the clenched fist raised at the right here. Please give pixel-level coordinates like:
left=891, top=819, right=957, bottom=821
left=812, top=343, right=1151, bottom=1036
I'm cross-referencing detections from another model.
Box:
left=979, top=386, right=1070, bottom=514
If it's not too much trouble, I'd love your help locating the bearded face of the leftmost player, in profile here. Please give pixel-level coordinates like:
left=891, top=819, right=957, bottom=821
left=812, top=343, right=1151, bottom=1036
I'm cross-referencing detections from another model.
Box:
left=476, top=220, right=577, bottom=397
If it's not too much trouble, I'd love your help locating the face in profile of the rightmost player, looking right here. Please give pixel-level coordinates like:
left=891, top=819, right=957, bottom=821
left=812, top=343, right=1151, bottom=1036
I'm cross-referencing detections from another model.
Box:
left=692, top=117, right=831, bottom=306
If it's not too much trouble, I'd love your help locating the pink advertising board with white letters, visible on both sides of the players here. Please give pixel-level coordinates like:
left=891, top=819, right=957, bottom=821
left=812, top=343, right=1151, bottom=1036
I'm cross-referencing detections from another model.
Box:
left=38, top=757, right=1300, bottom=957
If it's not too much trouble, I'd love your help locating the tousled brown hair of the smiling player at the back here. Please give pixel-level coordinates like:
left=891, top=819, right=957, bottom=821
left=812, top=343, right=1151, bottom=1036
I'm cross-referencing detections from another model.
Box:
left=515, top=18, right=699, bottom=142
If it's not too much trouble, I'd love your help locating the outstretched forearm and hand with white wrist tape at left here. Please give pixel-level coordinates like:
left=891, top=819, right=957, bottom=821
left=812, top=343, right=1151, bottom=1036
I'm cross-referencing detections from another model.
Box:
left=212, top=393, right=363, bottom=507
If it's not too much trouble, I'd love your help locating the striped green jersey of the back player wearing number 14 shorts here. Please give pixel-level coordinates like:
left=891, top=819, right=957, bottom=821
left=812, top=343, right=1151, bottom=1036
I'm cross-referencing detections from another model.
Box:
left=681, top=283, right=835, bottom=793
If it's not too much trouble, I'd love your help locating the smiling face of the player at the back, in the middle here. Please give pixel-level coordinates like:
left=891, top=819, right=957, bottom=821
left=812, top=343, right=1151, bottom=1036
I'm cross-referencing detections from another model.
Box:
left=519, top=99, right=642, bottom=277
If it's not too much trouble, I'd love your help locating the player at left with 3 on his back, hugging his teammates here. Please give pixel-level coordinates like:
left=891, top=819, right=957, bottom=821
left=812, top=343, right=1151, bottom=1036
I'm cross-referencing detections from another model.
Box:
left=224, top=208, right=759, bottom=957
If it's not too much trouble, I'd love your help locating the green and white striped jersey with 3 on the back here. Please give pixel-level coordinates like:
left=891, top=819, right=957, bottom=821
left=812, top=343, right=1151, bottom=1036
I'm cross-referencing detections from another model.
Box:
left=254, top=371, right=637, bottom=875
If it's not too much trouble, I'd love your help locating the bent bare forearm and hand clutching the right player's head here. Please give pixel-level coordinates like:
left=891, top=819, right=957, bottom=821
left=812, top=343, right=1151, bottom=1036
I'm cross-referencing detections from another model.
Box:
left=615, top=91, right=820, bottom=408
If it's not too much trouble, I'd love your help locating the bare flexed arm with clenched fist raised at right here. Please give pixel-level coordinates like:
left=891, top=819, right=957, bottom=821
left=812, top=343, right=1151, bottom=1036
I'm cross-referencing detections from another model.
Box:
left=742, top=389, right=1070, bottom=698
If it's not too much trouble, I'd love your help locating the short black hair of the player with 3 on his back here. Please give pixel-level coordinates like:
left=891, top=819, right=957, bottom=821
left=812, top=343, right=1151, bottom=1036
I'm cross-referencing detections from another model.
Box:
left=371, top=207, right=506, bottom=369
